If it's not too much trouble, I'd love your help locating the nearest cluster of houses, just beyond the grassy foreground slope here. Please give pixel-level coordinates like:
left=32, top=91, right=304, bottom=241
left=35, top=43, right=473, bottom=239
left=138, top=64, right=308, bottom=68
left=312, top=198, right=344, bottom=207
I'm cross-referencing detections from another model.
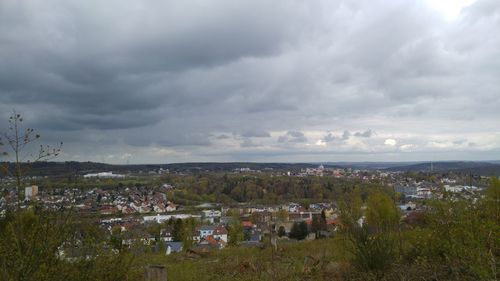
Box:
left=95, top=202, right=338, bottom=254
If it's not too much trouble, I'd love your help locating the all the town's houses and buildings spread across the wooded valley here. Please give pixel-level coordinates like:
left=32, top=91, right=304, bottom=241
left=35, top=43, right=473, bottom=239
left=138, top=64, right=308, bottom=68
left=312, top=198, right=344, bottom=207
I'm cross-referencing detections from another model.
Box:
left=0, top=166, right=490, bottom=254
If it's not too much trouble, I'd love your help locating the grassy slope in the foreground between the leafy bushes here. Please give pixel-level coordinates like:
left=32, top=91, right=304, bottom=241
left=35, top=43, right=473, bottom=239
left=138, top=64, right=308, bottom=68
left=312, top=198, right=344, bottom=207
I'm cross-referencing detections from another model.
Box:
left=129, top=238, right=346, bottom=281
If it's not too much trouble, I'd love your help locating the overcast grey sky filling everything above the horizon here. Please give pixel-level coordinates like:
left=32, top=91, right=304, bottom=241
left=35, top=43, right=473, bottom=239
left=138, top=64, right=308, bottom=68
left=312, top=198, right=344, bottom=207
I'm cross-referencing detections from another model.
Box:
left=0, top=0, right=500, bottom=164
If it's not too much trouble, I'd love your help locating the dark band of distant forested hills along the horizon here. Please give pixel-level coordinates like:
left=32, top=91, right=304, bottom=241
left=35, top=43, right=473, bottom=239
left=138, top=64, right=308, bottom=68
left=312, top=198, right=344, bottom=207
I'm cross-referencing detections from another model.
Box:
left=1, top=161, right=500, bottom=176
